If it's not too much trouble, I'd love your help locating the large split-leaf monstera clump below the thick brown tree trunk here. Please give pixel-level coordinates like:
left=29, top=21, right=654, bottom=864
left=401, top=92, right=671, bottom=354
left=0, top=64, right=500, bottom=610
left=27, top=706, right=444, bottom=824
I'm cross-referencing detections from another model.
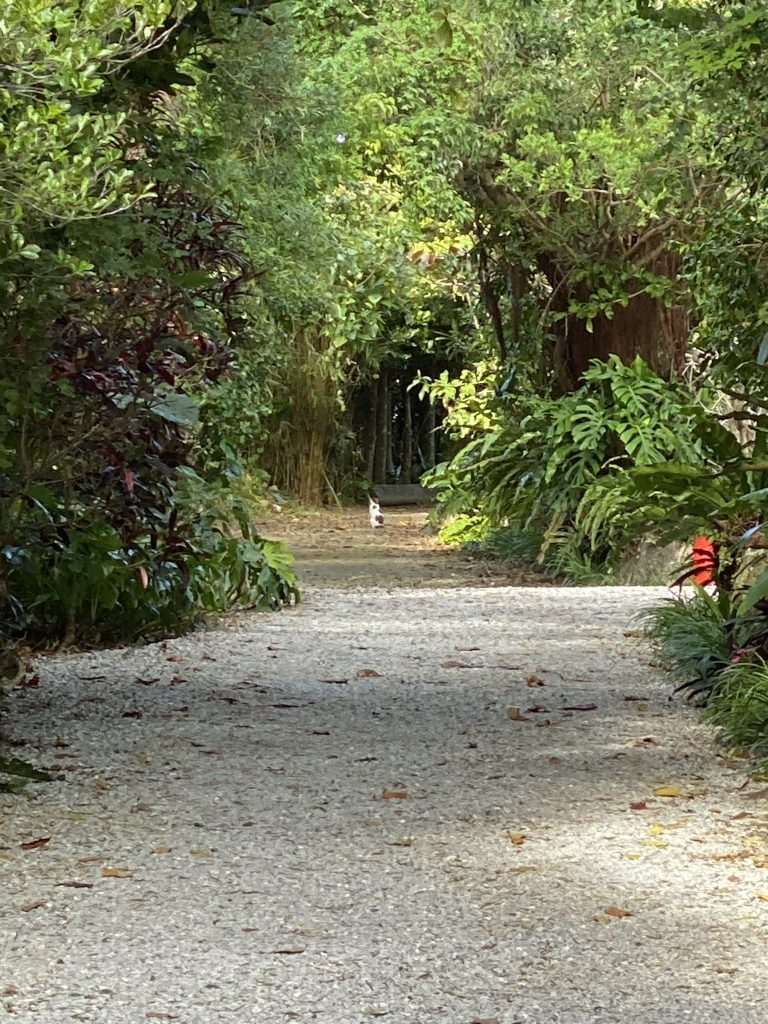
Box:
left=424, top=356, right=720, bottom=578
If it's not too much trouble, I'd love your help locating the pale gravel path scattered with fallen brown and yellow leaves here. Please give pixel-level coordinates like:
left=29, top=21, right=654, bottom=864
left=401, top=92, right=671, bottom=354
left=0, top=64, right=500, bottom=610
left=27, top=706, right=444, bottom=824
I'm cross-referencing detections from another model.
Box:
left=0, top=587, right=768, bottom=1024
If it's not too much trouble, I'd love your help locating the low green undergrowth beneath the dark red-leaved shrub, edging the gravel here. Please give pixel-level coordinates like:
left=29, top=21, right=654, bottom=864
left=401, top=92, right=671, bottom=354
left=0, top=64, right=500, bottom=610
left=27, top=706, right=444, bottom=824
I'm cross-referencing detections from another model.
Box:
left=3, top=469, right=297, bottom=642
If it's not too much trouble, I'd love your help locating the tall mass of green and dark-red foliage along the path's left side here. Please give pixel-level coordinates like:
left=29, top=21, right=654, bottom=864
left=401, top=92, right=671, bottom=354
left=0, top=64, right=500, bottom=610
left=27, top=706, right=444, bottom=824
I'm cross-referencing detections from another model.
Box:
left=0, top=0, right=295, bottom=655
